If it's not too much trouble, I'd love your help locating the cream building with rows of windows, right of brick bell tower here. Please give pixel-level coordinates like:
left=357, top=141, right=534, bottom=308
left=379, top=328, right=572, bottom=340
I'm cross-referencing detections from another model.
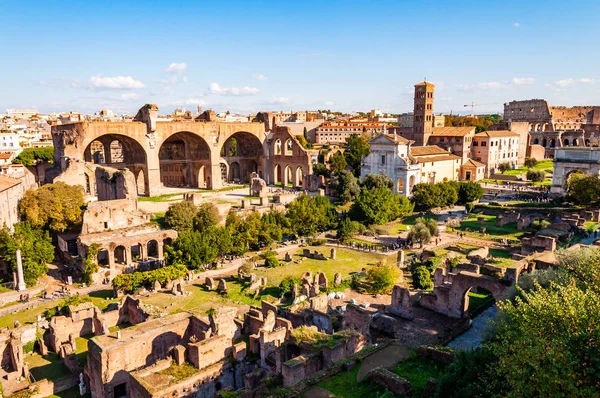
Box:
left=471, top=130, right=520, bottom=176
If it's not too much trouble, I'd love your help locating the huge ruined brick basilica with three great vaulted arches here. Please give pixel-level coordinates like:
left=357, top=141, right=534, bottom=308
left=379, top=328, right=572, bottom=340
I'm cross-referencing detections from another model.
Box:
left=52, top=104, right=317, bottom=196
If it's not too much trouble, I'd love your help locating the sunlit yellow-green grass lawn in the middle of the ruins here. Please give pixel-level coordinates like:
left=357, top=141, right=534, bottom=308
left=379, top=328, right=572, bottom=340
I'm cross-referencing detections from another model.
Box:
left=255, top=246, right=384, bottom=286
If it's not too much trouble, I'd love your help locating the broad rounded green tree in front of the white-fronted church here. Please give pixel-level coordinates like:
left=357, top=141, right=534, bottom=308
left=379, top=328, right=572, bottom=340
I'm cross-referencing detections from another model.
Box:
left=349, top=187, right=413, bottom=225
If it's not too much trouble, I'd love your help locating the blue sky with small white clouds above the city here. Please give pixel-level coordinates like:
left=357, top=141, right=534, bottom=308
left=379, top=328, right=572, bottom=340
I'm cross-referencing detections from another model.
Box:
left=0, top=0, right=600, bottom=113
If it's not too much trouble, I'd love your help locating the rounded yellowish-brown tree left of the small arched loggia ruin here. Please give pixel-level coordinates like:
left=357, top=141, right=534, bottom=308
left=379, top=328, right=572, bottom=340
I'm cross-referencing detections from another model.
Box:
left=19, top=182, right=84, bottom=232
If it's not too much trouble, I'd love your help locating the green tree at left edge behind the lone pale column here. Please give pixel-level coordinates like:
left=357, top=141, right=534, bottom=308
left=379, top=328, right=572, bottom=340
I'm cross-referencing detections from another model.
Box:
left=0, top=222, right=54, bottom=286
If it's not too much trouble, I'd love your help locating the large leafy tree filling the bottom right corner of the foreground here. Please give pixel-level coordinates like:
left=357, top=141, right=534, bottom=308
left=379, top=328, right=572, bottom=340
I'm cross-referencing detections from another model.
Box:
left=490, top=284, right=600, bottom=397
